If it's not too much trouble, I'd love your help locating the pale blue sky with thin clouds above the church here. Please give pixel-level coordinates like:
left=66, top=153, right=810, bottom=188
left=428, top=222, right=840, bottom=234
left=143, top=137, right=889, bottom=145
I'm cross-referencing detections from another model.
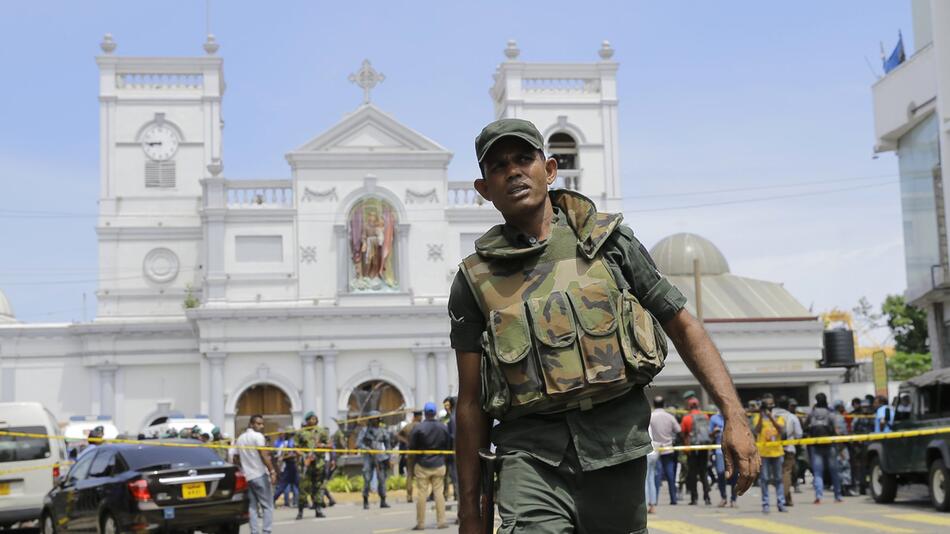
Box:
left=0, top=0, right=913, bottom=346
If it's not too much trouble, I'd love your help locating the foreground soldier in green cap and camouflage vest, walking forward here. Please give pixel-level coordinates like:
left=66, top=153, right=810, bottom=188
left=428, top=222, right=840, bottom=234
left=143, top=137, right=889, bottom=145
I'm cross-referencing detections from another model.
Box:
left=449, top=119, right=760, bottom=534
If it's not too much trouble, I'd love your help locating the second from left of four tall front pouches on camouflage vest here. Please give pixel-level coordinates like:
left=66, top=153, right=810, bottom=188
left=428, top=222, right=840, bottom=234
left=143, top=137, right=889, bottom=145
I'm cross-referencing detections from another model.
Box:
left=526, top=291, right=584, bottom=395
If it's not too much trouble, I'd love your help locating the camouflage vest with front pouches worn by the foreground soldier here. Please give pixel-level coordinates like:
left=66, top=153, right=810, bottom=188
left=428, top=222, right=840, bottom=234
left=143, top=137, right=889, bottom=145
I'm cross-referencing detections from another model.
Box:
left=460, top=191, right=666, bottom=420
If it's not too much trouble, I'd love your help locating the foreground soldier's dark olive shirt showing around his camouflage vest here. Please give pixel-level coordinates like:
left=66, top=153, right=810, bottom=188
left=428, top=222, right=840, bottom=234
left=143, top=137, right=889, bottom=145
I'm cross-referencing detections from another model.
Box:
left=449, top=208, right=686, bottom=471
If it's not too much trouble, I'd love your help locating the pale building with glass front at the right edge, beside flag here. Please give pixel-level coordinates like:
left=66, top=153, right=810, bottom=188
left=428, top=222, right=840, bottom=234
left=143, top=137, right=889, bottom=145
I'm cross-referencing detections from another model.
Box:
left=872, top=0, right=950, bottom=368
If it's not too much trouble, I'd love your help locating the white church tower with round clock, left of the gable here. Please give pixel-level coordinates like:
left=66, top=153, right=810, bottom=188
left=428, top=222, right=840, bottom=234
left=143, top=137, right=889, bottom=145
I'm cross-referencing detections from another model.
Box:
left=96, top=35, right=224, bottom=321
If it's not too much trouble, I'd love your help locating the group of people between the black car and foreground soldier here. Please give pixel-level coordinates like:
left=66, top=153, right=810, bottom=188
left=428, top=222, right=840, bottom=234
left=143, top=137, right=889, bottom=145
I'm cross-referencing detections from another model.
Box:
left=228, top=397, right=458, bottom=534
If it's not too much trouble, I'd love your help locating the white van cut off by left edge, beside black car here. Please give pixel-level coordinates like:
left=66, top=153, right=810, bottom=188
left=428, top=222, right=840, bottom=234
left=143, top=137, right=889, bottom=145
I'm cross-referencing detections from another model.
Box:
left=0, top=402, right=66, bottom=528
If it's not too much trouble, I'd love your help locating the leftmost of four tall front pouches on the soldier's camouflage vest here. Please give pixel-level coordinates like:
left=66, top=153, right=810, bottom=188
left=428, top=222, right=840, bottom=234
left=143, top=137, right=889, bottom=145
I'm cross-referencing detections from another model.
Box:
left=489, top=301, right=544, bottom=408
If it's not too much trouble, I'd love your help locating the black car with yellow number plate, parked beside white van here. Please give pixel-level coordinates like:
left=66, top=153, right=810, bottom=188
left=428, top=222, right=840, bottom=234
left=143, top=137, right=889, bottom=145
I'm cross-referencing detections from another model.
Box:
left=41, top=440, right=248, bottom=534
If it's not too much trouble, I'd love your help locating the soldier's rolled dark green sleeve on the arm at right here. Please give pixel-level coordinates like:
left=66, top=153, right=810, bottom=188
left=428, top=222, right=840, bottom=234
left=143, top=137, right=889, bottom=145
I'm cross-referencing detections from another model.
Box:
left=604, top=225, right=686, bottom=324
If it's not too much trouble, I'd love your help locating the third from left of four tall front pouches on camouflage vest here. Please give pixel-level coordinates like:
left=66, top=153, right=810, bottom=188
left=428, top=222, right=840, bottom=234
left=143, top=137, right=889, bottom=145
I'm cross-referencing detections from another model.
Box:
left=568, top=281, right=627, bottom=384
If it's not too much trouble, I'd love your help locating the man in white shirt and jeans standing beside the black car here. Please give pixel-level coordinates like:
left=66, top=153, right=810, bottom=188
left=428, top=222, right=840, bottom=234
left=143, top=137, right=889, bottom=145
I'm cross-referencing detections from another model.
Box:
left=235, top=414, right=277, bottom=534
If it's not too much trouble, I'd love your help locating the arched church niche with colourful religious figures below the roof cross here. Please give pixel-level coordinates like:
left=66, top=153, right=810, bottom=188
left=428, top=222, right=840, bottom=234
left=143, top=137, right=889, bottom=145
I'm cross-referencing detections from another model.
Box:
left=347, top=197, right=399, bottom=292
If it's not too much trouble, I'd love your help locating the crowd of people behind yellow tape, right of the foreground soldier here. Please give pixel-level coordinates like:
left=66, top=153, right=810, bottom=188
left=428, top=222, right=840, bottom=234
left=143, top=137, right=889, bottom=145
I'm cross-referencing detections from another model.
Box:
left=646, top=391, right=911, bottom=513
